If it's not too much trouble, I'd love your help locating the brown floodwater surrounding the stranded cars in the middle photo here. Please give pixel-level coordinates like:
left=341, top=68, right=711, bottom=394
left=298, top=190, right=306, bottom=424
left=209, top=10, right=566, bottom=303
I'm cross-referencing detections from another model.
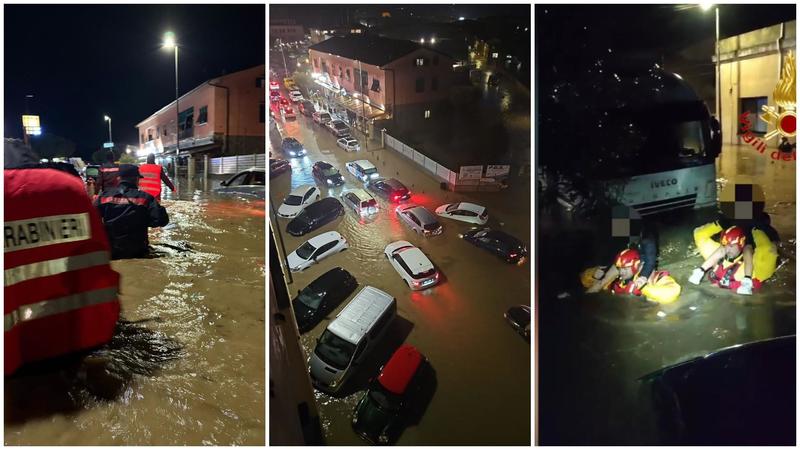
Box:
left=270, top=111, right=531, bottom=445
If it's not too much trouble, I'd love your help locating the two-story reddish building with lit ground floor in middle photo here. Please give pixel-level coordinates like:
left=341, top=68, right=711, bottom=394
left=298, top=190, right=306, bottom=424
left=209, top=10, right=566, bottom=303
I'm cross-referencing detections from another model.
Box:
left=309, top=35, right=454, bottom=134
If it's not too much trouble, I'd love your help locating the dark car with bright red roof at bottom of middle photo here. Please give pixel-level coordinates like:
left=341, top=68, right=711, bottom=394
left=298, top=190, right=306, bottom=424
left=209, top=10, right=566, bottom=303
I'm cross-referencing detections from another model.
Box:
left=353, top=344, right=425, bottom=444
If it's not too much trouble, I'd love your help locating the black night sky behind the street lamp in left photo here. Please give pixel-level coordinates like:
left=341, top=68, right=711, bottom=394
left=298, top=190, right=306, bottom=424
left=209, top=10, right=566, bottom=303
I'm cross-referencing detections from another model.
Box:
left=3, top=5, right=266, bottom=157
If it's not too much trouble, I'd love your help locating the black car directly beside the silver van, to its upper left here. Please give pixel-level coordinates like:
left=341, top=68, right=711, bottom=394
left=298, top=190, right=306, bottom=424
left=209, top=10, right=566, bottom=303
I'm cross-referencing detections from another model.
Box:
left=292, top=267, right=358, bottom=333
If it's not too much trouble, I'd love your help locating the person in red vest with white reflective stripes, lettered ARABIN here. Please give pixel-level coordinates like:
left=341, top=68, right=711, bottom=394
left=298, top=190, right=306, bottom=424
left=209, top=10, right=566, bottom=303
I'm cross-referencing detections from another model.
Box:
left=3, top=139, right=120, bottom=375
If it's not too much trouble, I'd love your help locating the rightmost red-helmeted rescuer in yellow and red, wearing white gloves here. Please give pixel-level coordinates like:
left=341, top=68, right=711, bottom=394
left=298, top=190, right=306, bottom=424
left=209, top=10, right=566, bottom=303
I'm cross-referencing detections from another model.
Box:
left=689, top=220, right=779, bottom=295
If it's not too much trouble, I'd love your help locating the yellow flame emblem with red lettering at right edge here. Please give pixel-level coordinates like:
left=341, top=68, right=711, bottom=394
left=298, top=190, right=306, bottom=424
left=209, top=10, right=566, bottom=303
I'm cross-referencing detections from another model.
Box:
left=759, top=52, right=797, bottom=141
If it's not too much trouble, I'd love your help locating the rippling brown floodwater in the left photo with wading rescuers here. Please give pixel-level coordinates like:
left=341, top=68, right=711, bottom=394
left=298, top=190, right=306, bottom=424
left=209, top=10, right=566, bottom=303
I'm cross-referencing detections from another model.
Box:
left=5, top=180, right=265, bottom=445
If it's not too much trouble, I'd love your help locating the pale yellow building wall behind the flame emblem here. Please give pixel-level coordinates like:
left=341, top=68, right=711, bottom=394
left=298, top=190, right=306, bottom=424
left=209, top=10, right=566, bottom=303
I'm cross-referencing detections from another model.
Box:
left=720, top=21, right=797, bottom=147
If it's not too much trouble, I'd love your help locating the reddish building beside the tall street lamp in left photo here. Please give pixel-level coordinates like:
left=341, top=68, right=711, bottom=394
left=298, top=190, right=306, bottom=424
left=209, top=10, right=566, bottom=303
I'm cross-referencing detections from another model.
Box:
left=136, top=65, right=266, bottom=157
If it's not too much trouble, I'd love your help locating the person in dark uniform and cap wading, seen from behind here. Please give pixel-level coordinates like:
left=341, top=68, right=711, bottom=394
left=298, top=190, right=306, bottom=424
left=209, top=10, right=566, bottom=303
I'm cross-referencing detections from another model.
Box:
left=95, top=164, right=169, bottom=259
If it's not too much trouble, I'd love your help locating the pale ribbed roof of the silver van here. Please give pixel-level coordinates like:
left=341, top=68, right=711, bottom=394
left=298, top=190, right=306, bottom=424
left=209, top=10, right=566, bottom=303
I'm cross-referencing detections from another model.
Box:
left=328, top=286, right=395, bottom=345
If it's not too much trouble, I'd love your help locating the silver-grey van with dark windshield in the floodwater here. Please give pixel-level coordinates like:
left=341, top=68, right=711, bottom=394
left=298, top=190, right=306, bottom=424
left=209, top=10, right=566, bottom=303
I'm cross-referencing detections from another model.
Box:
left=309, top=286, right=397, bottom=392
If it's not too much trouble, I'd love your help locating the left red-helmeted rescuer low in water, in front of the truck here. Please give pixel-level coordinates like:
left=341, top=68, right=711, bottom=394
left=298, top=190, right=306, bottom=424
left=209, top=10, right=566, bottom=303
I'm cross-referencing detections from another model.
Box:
left=581, top=248, right=681, bottom=304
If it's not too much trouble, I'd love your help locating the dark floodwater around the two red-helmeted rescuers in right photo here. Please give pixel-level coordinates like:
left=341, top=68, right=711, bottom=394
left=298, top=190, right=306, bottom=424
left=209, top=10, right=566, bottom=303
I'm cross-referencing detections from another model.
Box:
left=537, top=146, right=797, bottom=445
